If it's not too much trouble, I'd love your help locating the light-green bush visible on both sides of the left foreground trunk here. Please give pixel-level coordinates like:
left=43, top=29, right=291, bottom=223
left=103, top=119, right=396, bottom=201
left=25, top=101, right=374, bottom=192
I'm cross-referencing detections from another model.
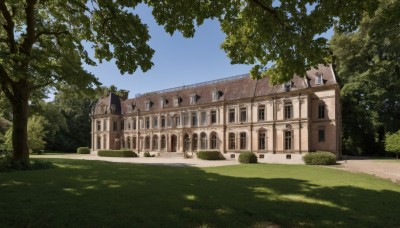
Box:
left=5, top=116, right=46, bottom=151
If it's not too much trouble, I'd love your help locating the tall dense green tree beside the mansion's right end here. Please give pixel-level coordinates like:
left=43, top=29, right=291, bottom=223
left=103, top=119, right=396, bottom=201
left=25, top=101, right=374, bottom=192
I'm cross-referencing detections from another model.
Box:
left=331, top=0, right=400, bottom=153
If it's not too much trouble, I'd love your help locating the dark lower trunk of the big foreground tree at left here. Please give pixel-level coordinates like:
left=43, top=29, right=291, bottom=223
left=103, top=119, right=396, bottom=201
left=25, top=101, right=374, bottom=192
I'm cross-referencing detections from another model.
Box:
left=11, top=94, right=29, bottom=166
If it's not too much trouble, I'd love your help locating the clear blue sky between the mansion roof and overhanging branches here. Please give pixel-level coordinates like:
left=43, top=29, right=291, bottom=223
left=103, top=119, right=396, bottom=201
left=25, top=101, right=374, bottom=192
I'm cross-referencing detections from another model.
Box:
left=85, top=5, right=331, bottom=97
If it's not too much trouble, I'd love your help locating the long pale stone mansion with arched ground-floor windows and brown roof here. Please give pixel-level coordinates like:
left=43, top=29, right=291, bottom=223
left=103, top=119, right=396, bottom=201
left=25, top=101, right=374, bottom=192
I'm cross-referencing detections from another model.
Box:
left=91, top=66, right=341, bottom=159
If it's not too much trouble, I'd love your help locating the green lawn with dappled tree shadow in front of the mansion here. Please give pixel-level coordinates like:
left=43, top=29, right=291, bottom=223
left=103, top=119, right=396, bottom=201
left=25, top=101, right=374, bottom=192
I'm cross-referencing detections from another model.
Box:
left=0, top=159, right=400, bottom=227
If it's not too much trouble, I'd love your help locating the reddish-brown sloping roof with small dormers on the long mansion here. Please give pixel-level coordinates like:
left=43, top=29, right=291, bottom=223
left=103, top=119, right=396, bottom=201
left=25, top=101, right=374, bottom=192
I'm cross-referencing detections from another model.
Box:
left=96, top=65, right=337, bottom=114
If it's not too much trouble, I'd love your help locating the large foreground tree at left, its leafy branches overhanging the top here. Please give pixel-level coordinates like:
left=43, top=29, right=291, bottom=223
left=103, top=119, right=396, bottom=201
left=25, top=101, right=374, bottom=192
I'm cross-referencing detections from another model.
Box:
left=0, top=0, right=378, bottom=164
